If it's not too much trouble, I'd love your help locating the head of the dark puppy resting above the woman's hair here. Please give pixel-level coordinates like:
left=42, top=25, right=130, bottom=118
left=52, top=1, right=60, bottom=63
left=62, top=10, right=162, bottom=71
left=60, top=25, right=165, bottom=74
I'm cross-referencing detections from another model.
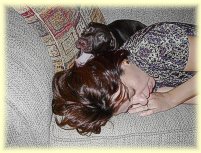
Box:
left=76, top=22, right=115, bottom=55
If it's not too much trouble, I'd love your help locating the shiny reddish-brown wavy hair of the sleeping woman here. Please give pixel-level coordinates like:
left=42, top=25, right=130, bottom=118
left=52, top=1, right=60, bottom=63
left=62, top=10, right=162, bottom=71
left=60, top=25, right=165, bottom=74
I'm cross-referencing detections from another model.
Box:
left=52, top=50, right=129, bottom=134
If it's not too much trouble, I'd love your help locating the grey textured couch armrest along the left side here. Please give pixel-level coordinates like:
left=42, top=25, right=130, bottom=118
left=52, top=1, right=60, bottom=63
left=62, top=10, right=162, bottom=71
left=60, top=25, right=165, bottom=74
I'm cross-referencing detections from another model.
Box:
left=6, top=8, right=53, bottom=147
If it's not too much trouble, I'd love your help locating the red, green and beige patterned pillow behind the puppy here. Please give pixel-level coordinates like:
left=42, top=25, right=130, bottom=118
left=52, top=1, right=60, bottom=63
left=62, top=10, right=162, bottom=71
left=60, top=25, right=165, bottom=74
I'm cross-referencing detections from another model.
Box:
left=14, top=6, right=105, bottom=72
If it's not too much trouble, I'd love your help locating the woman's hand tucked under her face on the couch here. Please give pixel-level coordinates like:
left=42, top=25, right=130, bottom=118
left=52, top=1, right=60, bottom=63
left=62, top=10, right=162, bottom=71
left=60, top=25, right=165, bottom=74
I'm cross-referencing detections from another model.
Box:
left=128, top=92, right=175, bottom=116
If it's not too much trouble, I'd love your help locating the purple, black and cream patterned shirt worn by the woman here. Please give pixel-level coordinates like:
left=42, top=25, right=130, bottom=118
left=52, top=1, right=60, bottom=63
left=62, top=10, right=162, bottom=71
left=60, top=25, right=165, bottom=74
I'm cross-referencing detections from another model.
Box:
left=121, top=22, right=196, bottom=89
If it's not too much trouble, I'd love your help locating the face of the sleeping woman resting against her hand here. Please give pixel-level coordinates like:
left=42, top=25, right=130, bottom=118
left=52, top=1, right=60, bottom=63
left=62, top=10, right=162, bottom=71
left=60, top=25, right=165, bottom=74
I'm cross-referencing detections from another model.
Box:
left=115, top=60, right=155, bottom=114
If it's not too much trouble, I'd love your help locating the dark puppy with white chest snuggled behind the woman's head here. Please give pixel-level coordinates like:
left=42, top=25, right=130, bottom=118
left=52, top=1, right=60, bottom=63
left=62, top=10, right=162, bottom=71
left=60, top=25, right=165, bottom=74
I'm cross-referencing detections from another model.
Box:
left=76, top=20, right=146, bottom=57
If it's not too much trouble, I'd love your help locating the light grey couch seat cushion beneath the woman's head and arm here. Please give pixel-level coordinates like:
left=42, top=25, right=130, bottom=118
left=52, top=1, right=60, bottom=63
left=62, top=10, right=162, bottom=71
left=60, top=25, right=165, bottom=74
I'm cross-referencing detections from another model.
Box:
left=50, top=104, right=196, bottom=147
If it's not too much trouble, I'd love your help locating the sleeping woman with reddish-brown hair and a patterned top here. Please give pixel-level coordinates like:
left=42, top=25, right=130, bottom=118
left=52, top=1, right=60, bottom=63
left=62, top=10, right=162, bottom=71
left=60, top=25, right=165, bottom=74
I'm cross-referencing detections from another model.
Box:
left=52, top=22, right=197, bottom=134
